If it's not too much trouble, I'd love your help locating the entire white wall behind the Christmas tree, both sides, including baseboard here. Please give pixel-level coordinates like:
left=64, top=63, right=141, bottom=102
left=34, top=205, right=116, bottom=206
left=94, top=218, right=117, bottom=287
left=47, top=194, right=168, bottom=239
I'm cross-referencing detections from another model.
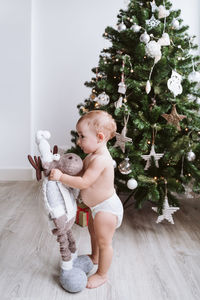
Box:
left=0, top=0, right=200, bottom=180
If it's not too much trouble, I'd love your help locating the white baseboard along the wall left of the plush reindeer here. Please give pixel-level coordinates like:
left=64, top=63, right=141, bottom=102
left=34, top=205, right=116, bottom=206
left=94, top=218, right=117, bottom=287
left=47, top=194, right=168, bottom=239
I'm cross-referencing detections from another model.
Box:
left=0, top=169, right=35, bottom=181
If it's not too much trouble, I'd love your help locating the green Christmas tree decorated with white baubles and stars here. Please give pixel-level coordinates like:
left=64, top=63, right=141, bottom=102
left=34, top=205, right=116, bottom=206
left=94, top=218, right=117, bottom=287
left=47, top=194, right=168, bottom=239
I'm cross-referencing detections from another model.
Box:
left=70, top=0, right=200, bottom=221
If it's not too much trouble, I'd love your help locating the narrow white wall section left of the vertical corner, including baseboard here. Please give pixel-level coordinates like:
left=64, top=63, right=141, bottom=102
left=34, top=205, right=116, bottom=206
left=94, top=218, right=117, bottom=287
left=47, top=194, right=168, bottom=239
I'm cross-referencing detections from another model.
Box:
left=0, top=0, right=31, bottom=179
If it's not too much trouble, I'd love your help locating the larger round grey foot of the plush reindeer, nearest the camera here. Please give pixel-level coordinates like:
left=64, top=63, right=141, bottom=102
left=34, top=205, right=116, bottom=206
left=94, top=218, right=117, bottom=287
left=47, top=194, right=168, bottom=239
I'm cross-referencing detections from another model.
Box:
left=60, top=268, right=87, bottom=293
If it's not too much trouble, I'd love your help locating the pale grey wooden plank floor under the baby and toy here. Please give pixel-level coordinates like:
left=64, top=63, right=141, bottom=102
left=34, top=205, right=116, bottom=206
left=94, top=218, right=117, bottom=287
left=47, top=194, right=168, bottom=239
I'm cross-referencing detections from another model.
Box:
left=0, top=182, right=200, bottom=300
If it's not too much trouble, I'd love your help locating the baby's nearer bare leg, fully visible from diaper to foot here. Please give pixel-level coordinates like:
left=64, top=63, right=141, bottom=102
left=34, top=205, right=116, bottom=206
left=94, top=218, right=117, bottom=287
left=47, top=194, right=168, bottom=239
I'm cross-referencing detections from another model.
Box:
left=87, top=211, right=117, bottom=288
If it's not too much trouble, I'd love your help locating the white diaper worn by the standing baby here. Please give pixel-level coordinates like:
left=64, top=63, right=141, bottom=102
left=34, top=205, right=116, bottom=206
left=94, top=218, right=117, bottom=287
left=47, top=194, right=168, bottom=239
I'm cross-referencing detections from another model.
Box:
left=90, top=193, right=124, bottom=228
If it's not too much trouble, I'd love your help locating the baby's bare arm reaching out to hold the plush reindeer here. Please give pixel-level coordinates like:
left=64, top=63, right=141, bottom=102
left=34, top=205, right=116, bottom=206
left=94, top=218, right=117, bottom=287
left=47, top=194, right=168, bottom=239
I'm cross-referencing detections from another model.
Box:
left=49, top=157, right=105, bottom=190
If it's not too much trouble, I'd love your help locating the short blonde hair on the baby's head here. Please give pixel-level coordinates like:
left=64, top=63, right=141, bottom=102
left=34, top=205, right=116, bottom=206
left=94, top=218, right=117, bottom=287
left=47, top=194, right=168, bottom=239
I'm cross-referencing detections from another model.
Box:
left=76, top=110, right=117, bottom=140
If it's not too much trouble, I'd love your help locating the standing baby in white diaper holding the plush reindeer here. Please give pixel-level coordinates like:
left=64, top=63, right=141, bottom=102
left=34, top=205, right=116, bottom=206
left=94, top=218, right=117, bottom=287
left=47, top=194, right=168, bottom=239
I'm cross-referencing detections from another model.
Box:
left=50, top=110, right=123, bottom=288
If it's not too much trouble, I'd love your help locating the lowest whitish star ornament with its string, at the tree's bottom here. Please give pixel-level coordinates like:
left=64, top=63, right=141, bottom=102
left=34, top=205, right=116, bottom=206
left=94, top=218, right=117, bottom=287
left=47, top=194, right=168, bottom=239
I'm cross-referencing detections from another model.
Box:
left=152, top=180, right=179, bottom=224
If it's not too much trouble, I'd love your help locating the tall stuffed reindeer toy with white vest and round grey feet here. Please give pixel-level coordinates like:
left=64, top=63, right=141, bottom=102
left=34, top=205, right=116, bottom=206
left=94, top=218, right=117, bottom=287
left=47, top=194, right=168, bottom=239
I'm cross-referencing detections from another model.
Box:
left=28, top=130, right=93, bottom=293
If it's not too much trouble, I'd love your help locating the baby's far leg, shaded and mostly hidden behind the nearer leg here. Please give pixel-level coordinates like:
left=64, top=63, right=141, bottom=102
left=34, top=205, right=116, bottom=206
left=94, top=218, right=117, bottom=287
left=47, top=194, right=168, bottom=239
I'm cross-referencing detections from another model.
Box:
left=88, top=211, right=99, bottom=264
